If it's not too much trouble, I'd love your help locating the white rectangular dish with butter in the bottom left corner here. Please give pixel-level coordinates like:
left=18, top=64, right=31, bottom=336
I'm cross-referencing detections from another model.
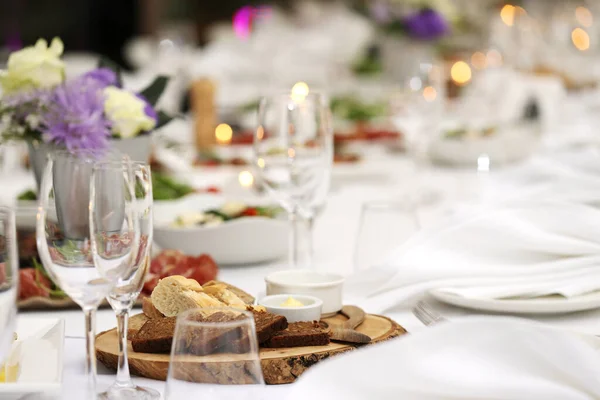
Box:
left=0, top=318, right=65, bottom=400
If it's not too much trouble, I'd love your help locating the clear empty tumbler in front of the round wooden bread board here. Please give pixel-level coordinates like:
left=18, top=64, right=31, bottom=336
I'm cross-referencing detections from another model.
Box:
left=165, top=308, right=264, bottom=400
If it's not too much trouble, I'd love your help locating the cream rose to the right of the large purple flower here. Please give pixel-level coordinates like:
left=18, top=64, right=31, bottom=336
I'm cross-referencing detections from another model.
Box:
left=104, top=86, right=156, bottom=138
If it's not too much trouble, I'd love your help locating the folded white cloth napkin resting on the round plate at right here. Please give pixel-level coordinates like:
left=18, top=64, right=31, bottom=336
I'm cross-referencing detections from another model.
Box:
left=346, top=200, right=600, bottom=312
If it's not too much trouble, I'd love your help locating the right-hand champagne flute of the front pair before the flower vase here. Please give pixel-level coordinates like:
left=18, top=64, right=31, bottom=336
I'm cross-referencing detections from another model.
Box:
left=95, top=161, right=160, bottom=400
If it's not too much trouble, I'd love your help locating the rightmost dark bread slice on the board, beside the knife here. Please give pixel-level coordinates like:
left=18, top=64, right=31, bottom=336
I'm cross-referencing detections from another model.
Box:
left=263, top=321, right=329, bottom=348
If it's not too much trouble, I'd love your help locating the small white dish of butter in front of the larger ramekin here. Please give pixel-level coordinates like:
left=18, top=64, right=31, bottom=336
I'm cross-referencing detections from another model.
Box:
left=258, top=294, right=323, bottom=322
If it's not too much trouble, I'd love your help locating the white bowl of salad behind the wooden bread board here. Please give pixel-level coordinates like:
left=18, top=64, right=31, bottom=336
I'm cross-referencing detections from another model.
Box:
left=154, top=195, right=289, bottom=265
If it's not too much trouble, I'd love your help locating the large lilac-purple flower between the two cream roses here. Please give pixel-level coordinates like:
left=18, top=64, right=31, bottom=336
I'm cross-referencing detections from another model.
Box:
left=41, top=74, right=111, bottom=151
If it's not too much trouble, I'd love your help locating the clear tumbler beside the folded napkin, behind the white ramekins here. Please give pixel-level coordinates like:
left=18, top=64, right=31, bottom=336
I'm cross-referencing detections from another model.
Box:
left=354, top=202, right=419, bottom=273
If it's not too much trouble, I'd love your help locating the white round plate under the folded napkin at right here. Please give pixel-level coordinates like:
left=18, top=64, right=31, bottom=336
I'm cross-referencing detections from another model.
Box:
left=429, top=289, right=600, bottom=314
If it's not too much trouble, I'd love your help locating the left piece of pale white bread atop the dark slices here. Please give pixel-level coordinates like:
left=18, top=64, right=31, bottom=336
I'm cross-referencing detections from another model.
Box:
left=150, top=275, right=225, bottom=317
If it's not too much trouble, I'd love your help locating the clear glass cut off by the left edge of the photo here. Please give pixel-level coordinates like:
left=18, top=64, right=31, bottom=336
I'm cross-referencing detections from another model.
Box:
left=0, top=207, right=19, bottom=364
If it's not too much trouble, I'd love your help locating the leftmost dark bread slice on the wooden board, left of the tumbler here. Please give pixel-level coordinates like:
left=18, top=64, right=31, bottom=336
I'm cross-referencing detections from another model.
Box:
left=131, top=317, right=177, bottom=354
